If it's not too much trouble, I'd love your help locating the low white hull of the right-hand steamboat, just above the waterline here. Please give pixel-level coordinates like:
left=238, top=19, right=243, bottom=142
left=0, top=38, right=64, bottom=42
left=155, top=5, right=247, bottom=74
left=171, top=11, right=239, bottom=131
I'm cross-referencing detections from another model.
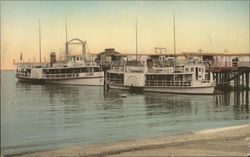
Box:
left=109, top=85, right=215, bottom=94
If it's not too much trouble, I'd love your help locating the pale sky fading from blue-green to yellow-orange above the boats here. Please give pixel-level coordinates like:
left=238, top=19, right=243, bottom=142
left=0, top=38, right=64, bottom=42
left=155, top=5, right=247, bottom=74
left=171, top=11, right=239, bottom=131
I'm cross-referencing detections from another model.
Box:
left=1, top=1, right=249, bottom=69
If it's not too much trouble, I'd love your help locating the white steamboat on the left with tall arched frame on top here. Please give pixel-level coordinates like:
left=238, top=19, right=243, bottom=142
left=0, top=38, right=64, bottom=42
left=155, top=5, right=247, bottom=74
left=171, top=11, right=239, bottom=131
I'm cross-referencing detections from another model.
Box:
left=15, top=39, right=104, bottom=85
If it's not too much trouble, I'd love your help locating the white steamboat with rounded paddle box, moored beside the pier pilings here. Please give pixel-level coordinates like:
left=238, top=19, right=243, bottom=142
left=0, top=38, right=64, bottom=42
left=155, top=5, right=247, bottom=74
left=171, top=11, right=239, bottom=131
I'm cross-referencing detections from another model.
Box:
left=106, top=60, right=215, bottom=94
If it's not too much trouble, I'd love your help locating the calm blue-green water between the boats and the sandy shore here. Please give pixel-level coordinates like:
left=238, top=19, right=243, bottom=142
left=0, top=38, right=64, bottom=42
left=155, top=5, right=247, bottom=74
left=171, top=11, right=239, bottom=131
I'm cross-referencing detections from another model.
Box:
left=1, top=71, right=249, bottom=155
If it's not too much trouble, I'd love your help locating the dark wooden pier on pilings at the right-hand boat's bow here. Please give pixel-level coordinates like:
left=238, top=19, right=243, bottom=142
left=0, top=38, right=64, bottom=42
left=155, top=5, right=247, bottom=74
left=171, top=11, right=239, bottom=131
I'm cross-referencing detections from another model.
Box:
left=207, top=62, right=250, bottom=90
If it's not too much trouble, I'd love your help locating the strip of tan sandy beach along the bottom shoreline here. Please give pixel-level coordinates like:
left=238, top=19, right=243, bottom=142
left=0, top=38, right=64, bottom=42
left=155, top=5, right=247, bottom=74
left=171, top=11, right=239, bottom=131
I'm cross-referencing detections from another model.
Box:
left=6, top=125, right=250, bottom=157
